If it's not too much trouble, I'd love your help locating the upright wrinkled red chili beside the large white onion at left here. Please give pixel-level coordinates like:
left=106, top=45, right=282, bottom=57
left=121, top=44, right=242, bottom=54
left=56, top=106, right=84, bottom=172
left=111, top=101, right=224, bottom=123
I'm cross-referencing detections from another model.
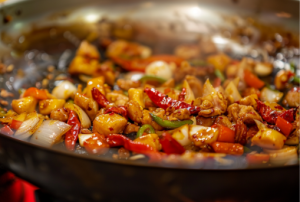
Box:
left=65, top=110, right=80, bottom=151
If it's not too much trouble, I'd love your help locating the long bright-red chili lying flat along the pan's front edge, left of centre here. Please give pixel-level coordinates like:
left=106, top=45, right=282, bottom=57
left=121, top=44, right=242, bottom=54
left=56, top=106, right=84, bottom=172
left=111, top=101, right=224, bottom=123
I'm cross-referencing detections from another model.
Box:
left=106, top=134, right=156, bottom=154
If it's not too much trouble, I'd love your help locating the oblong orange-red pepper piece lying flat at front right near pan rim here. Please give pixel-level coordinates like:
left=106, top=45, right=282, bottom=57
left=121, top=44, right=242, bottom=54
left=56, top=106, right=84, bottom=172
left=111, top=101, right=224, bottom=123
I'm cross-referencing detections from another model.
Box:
left=211, top=142, right=244, bottom=155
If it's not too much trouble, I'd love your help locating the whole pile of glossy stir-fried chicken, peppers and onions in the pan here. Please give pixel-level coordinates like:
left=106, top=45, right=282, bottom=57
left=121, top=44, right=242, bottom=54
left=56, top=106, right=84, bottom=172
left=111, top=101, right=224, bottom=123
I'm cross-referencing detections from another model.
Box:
left=0, top=40, right=300, bottom=165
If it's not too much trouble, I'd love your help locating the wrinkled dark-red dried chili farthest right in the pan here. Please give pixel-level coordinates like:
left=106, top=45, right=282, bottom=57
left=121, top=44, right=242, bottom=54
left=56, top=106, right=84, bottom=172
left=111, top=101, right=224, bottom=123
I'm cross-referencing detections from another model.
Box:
left=256, top=100, right=297, bottom=124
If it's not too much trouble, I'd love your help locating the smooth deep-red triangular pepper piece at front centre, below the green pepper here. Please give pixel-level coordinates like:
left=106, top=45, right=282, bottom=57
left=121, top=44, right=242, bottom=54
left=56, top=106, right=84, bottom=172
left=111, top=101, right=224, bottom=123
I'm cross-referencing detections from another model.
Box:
left=159, top=132, right=185, bottom=154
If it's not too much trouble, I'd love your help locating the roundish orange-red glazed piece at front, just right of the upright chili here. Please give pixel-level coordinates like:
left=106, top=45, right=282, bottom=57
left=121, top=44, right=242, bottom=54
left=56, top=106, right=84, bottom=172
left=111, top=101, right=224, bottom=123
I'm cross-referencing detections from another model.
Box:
left=83, top=133, right=109, bottom=154
